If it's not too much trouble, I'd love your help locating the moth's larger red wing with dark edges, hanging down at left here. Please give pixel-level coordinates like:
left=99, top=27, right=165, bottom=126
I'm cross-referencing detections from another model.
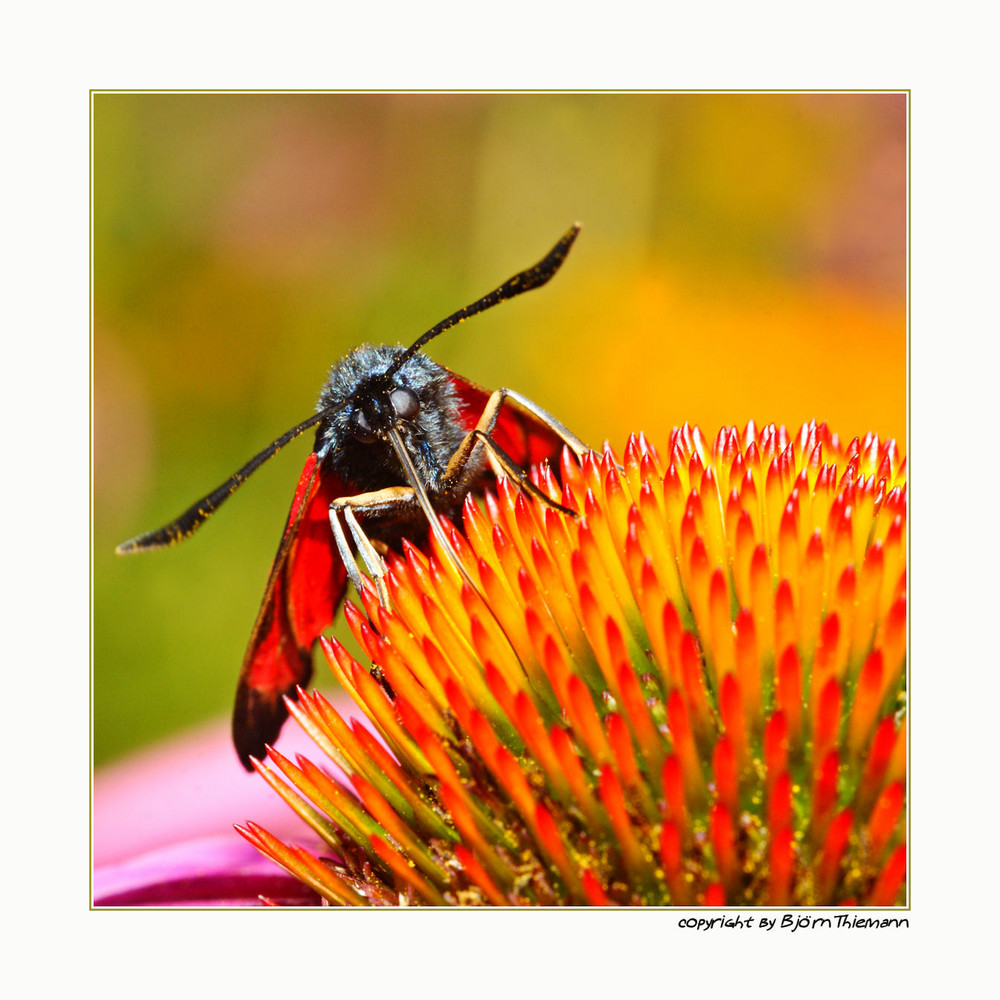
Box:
left=233, top=454, right=349, bottom=770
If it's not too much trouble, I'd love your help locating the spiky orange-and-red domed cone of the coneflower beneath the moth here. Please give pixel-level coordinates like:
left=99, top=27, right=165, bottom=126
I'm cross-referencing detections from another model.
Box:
left=241, top=422, right=907, bottom=906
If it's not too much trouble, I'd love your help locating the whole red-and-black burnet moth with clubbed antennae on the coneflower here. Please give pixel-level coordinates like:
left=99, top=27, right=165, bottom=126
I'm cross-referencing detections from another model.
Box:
left=116, top=225, right=589, bottom=770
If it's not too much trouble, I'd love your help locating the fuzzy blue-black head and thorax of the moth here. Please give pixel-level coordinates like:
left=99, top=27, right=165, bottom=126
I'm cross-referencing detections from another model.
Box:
left=316, top=344, right=469, bottom=493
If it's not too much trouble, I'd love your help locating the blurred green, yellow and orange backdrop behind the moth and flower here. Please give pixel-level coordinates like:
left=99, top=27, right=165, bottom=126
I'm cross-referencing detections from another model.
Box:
left=93, top=93, right=907, bottom=764
